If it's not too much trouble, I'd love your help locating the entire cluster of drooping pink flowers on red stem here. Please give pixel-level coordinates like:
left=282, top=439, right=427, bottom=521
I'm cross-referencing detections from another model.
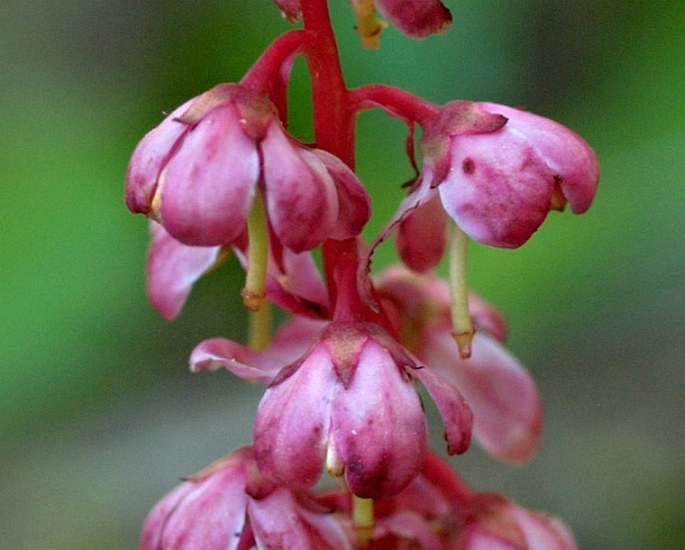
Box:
left=126, top=0, right=599, bottom=549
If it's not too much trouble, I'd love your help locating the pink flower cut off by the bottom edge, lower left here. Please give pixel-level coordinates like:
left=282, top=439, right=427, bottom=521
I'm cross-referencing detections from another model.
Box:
left=140, top=448, right=349, bottom=550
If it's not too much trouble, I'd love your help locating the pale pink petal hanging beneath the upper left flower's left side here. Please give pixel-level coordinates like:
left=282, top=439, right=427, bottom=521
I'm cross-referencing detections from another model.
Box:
left=146, top=222, right=221, bottom=319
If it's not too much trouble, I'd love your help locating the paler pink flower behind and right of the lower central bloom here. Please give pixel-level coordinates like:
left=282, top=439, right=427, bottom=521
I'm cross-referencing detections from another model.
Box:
left=377, top=268, right=542, bottom=464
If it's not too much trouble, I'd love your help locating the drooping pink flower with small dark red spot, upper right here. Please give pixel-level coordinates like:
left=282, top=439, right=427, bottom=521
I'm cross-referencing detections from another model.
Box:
left=412, top=101, right=599, bottom=248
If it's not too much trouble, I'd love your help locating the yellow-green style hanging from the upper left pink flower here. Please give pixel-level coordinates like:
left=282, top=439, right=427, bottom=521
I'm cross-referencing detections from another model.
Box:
left=240, top=192, right=269, bottom=311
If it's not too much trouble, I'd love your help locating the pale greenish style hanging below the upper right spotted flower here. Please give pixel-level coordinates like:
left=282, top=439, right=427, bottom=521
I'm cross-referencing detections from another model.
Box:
left=449, top=223, right=476, bottom=359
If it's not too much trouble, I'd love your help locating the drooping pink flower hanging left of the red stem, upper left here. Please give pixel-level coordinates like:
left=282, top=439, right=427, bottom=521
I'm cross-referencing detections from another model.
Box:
left=126, top=84, right=369, bottom=252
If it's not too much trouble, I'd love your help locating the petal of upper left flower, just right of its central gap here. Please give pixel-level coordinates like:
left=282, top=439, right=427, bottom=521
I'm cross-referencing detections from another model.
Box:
left=261, top=124, right=338, bottom=252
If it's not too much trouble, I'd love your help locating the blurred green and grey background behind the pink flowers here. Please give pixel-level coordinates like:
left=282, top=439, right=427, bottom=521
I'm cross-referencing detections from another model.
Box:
left=0, top=0, right=685, bottom=549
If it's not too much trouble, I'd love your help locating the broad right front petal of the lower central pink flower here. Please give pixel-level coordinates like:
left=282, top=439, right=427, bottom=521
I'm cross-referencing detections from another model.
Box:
left=329, top=339, right=427, bottom=498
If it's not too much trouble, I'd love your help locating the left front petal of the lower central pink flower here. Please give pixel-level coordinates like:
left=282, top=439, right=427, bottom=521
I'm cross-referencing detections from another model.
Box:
left=254, top=346, right=337, bottom=487
